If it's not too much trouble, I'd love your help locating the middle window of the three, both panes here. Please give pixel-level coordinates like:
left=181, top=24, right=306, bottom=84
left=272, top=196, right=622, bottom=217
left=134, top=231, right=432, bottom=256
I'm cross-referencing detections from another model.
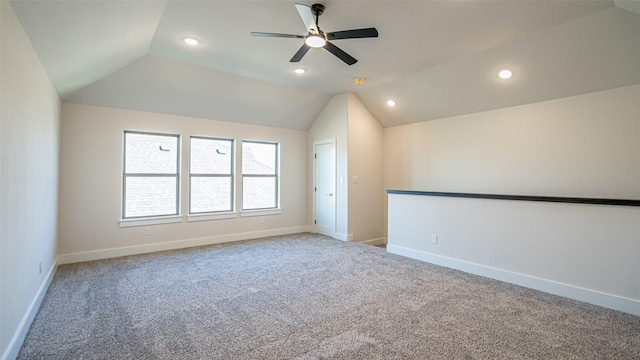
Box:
left=189, top=136, right=234, bottom=214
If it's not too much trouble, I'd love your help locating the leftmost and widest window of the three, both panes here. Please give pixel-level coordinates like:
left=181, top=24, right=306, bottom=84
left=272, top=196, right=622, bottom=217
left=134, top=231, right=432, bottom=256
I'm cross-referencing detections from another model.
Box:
left=122, top=131, right=180, bottom=219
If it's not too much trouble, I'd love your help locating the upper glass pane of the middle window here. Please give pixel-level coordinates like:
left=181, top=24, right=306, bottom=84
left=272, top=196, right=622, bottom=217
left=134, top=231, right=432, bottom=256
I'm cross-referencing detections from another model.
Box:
left=190, top=138, right=233, bottom=175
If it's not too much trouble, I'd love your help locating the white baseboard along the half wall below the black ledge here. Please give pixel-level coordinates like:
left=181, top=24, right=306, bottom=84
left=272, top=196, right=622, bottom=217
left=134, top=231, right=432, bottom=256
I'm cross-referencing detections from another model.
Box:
left=387, top=244, right=640, bottom=316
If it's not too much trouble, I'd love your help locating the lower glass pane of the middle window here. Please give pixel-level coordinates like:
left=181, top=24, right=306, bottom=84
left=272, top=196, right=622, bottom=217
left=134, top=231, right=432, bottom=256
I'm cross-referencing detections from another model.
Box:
left=190, top=176, right=233, bottom=213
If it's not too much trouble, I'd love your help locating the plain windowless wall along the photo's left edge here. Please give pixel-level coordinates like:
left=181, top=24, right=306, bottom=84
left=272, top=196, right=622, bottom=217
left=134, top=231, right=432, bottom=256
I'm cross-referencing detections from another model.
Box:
left=0, top=1, right=60, bottom=359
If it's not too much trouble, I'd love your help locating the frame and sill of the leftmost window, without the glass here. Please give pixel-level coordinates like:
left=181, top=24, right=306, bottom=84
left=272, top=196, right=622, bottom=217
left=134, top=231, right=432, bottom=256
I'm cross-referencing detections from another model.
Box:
left=119, top=130, right=182, bottom=227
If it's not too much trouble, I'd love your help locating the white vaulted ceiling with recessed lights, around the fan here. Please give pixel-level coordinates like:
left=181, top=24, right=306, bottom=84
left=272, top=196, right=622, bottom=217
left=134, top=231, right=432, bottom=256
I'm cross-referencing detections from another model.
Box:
left=11, top=0, right=640, bottom=130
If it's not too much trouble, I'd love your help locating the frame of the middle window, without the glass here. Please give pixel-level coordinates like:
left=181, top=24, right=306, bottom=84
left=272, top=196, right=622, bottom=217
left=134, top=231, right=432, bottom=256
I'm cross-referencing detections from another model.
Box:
left=187, top=135, right=236, bottom=221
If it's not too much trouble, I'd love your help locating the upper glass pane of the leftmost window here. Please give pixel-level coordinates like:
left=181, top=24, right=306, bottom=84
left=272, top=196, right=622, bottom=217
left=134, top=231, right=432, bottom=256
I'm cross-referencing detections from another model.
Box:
left=124, top=133, right=179, bottom=174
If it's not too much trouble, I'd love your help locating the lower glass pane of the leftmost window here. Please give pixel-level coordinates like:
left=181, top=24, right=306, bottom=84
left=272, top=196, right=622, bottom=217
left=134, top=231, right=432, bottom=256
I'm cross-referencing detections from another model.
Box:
left=124, top=176, right=177, bottom=218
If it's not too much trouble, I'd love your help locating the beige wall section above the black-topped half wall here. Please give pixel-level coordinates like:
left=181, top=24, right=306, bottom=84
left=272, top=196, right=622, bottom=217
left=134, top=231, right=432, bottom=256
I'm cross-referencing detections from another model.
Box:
left=385, top=85, right=640, bottom=199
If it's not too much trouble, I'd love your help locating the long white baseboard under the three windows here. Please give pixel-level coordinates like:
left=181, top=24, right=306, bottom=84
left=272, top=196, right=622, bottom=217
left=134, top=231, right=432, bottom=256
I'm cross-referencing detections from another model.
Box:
left=58, top=226, right=310, bottom=265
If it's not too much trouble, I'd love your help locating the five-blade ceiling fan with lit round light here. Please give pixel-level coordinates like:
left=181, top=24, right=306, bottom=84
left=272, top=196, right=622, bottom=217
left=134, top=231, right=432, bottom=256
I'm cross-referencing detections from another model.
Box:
left=251, top=4, right=378, bottom=65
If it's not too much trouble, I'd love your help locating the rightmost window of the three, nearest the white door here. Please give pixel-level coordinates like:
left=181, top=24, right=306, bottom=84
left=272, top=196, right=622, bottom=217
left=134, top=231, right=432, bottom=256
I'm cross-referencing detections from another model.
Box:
left=242, top=140, right=279, bottom=210
